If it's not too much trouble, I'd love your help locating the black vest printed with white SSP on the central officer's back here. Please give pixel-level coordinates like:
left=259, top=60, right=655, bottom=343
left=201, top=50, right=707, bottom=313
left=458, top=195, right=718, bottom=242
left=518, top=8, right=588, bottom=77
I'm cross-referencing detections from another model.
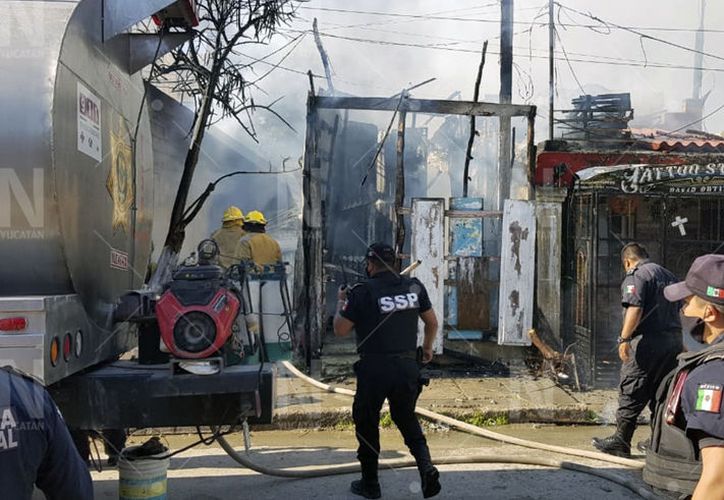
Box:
left=355, top=273, right=421, bottom=355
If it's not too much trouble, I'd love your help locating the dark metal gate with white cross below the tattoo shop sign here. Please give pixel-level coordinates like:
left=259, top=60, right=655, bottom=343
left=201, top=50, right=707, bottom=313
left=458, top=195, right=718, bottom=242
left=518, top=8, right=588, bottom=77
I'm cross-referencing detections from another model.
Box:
left=566, top=191, right=724, bottom=387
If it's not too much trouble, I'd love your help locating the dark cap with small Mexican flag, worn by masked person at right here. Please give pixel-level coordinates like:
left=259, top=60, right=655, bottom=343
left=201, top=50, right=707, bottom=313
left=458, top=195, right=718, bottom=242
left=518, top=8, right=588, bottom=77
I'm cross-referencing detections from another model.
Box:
left=664, top=254, right=724, bottom=305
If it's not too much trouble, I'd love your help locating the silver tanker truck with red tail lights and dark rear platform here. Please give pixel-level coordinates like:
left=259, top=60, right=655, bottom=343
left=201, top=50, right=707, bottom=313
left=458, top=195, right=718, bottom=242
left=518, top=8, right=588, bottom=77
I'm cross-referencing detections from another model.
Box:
left=0, top=0, right=274, bottom=429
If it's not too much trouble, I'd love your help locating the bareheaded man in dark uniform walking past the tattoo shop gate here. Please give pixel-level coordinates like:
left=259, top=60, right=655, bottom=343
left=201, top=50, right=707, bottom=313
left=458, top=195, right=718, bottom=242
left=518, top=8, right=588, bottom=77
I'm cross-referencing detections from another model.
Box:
left=593, top=243, right=683, bottom=457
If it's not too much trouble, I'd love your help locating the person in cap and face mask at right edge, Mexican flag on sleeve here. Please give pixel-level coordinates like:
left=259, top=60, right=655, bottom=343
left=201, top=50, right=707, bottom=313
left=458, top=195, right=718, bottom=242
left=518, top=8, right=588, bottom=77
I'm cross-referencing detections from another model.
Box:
left=644, top=255, right=724, bottom=500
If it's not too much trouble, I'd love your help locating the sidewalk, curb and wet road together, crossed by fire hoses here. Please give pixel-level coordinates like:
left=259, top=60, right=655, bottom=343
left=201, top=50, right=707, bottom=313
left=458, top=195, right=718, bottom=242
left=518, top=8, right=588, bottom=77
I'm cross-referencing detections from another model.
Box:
left=68, top=367, right=649, bottom=500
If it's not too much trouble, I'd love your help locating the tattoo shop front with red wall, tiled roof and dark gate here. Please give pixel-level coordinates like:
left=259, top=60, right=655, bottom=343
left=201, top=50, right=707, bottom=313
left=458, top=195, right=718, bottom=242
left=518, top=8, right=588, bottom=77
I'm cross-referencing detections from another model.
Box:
left=536, top=94, right=724, bottom=387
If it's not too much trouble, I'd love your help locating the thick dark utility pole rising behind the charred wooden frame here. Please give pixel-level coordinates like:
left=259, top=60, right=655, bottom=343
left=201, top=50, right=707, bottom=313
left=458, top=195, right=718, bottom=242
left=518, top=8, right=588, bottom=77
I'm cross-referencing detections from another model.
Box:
left=498, top=0, right=513, bottom=210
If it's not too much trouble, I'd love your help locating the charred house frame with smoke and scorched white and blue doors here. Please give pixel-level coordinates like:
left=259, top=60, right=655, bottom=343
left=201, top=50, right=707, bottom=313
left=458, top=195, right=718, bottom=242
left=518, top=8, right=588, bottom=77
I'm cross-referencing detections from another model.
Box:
left=296, top=94, right=535, bottom=362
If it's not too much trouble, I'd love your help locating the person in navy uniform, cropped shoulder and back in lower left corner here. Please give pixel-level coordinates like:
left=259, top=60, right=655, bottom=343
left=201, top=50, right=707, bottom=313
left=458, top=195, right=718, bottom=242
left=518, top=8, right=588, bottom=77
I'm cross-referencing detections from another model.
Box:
left=0, top=367, right=93, bottom=500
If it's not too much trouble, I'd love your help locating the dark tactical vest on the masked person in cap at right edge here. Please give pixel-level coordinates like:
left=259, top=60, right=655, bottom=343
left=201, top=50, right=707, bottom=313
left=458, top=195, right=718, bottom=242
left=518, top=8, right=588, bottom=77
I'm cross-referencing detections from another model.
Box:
left=643, top=343, right=724, bottom=495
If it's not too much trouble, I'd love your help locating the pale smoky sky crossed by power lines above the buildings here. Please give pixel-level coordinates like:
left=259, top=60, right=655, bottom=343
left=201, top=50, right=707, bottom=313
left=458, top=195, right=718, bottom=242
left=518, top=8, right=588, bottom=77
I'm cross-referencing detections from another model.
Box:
left=219, top=0, right=724, bottom=162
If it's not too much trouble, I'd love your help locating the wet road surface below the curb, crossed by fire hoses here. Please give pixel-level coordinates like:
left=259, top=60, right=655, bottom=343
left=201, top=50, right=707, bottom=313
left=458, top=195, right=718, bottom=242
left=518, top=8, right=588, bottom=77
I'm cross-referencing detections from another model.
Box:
left=85, top=424, right=646, bottom=500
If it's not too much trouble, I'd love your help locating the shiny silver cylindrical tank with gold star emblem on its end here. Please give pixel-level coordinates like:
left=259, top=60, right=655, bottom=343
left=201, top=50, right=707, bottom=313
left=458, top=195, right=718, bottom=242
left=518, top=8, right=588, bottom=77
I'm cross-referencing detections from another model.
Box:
left=0, top=0, right=156, bottom=379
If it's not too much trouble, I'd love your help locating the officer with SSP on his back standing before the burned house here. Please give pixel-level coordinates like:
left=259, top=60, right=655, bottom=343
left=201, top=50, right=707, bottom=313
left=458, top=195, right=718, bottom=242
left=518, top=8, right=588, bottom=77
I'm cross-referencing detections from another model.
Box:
left=334, top=243, right=441, bottom=498
